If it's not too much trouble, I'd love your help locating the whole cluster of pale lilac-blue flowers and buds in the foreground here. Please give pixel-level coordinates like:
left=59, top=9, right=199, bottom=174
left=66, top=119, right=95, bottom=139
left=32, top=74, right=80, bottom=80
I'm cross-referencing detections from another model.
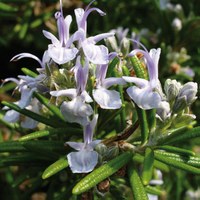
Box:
left=4, top=2, right=197, bottom=173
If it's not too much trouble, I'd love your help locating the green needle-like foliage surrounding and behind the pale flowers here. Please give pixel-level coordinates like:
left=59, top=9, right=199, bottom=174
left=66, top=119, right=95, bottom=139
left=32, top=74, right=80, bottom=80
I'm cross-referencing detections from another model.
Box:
left=0, top=0, right=200, bottom=200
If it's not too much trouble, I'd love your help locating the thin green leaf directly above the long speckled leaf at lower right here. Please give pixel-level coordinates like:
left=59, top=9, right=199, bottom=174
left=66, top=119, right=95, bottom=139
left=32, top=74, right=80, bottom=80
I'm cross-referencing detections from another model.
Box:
left=155, top=145, right=195, bottom=156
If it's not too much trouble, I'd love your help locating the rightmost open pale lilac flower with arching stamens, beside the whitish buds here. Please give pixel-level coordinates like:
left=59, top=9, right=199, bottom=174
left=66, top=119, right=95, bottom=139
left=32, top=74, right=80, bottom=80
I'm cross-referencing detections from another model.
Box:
left=122, top=48, right=163, bottom=110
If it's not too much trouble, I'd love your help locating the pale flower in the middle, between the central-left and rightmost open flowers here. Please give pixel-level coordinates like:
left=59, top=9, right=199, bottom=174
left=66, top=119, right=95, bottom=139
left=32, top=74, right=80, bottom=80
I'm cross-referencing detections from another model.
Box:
left=92, top=65, right=126, bottom=109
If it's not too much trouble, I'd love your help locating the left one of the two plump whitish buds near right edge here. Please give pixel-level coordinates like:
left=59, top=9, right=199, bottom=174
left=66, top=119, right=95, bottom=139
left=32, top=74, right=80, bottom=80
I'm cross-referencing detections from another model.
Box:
left=164, top=79, right=181, bottom=101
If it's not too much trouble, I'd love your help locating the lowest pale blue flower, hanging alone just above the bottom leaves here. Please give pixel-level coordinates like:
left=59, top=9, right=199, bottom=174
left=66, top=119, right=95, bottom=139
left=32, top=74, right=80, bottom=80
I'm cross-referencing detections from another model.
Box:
left=66, top=115, right=101, bottom=173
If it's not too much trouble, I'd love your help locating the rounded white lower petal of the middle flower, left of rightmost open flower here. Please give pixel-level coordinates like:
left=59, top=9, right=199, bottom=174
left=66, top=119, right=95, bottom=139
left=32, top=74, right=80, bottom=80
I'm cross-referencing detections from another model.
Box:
left=93, top=87, right=122, bottom=109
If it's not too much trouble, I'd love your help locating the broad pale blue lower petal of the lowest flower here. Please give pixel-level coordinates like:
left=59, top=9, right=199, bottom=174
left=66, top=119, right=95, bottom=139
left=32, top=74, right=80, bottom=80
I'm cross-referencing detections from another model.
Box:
left=67, top=151, right=98, bottom=173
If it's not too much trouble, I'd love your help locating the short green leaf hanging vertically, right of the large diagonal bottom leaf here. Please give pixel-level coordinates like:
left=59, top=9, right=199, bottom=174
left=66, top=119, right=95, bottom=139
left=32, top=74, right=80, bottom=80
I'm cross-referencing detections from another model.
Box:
left=141, top=147, right=154, bottom=185
